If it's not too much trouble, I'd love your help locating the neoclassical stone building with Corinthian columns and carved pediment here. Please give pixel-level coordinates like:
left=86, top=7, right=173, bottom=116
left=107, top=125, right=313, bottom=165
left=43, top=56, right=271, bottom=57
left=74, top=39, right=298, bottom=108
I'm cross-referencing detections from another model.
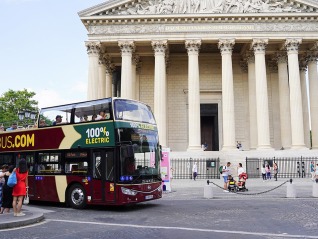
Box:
left=79, top=0, right=318, bottom=155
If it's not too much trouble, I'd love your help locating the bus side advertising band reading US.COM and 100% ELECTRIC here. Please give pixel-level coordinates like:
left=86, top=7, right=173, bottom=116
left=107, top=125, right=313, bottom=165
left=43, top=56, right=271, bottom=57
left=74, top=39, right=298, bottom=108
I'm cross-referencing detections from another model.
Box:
left=0, top=122, right=115, bottom=152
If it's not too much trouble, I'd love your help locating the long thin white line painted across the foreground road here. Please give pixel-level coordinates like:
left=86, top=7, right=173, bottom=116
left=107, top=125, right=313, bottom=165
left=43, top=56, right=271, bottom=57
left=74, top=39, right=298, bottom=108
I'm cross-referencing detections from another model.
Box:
left=47, top=219, right=318, bottom=239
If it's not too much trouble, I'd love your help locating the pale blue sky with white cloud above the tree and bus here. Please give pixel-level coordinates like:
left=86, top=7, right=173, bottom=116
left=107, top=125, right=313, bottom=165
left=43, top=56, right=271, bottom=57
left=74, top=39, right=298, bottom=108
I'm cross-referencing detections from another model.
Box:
left=0, top=0, right=105, bottom=108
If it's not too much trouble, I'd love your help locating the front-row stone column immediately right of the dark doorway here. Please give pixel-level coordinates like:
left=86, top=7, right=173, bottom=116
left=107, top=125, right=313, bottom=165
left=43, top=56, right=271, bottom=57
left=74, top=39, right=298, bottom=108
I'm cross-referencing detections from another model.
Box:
left=218, top=39, right=236, bottom=150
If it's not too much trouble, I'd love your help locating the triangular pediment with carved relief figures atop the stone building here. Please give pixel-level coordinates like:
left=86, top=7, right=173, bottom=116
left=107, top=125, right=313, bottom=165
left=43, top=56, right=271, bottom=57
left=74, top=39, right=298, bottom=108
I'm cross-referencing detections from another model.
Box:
left=79, top=0, right=318, bottom=17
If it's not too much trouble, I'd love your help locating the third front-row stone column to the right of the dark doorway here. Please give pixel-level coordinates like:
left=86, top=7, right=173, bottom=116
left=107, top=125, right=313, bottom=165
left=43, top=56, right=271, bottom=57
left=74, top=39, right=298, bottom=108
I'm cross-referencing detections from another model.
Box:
left=285, top=39, right=305, bottom=149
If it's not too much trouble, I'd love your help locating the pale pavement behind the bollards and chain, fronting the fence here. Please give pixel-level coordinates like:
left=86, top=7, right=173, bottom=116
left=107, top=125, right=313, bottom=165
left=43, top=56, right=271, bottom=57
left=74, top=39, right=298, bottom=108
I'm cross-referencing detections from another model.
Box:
left=163, top=178, right=318, bottom=200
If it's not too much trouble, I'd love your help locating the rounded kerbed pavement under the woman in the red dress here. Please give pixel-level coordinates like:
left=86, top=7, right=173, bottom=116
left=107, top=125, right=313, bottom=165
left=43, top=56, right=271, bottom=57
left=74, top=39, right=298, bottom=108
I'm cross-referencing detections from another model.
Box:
left=0, top=205, right=44, bottom=230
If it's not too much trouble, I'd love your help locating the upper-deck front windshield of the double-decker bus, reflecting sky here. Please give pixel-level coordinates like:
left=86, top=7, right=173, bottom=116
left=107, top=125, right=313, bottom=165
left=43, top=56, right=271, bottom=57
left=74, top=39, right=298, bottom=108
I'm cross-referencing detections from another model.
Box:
left=114, top=99, right=156, bottom=124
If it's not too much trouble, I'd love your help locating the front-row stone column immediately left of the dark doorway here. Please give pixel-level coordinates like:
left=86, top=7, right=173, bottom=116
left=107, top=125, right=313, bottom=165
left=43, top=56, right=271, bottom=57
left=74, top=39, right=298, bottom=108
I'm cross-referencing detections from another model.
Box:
left=185, top=40, right=202, bottom=151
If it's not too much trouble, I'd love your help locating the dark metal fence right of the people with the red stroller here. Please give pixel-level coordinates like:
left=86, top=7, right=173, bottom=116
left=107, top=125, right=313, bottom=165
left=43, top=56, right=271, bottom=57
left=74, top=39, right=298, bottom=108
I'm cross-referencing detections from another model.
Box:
left=246, top=157, right=318, bottom=178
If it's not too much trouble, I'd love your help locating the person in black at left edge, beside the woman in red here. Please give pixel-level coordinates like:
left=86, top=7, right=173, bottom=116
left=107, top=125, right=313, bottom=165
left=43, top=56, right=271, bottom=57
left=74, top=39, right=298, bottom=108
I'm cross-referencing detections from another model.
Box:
left=0, top=165, right=13, bottom=214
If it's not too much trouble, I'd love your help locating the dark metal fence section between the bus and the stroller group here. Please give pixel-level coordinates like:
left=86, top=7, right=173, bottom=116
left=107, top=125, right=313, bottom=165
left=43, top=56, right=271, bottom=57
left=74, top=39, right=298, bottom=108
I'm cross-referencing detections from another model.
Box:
left=171, top=158, right=220, bottom=179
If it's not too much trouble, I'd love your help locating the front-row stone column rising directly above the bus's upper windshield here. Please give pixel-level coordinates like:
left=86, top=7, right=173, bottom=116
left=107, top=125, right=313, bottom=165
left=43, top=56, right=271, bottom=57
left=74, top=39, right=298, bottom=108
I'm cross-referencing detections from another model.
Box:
left=118, top=41, right=135, bottom=99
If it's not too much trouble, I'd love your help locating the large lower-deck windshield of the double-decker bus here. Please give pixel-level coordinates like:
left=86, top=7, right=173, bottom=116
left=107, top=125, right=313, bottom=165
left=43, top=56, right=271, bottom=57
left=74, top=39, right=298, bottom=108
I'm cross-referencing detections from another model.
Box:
left=119, top=129, right=161, bottom=183
